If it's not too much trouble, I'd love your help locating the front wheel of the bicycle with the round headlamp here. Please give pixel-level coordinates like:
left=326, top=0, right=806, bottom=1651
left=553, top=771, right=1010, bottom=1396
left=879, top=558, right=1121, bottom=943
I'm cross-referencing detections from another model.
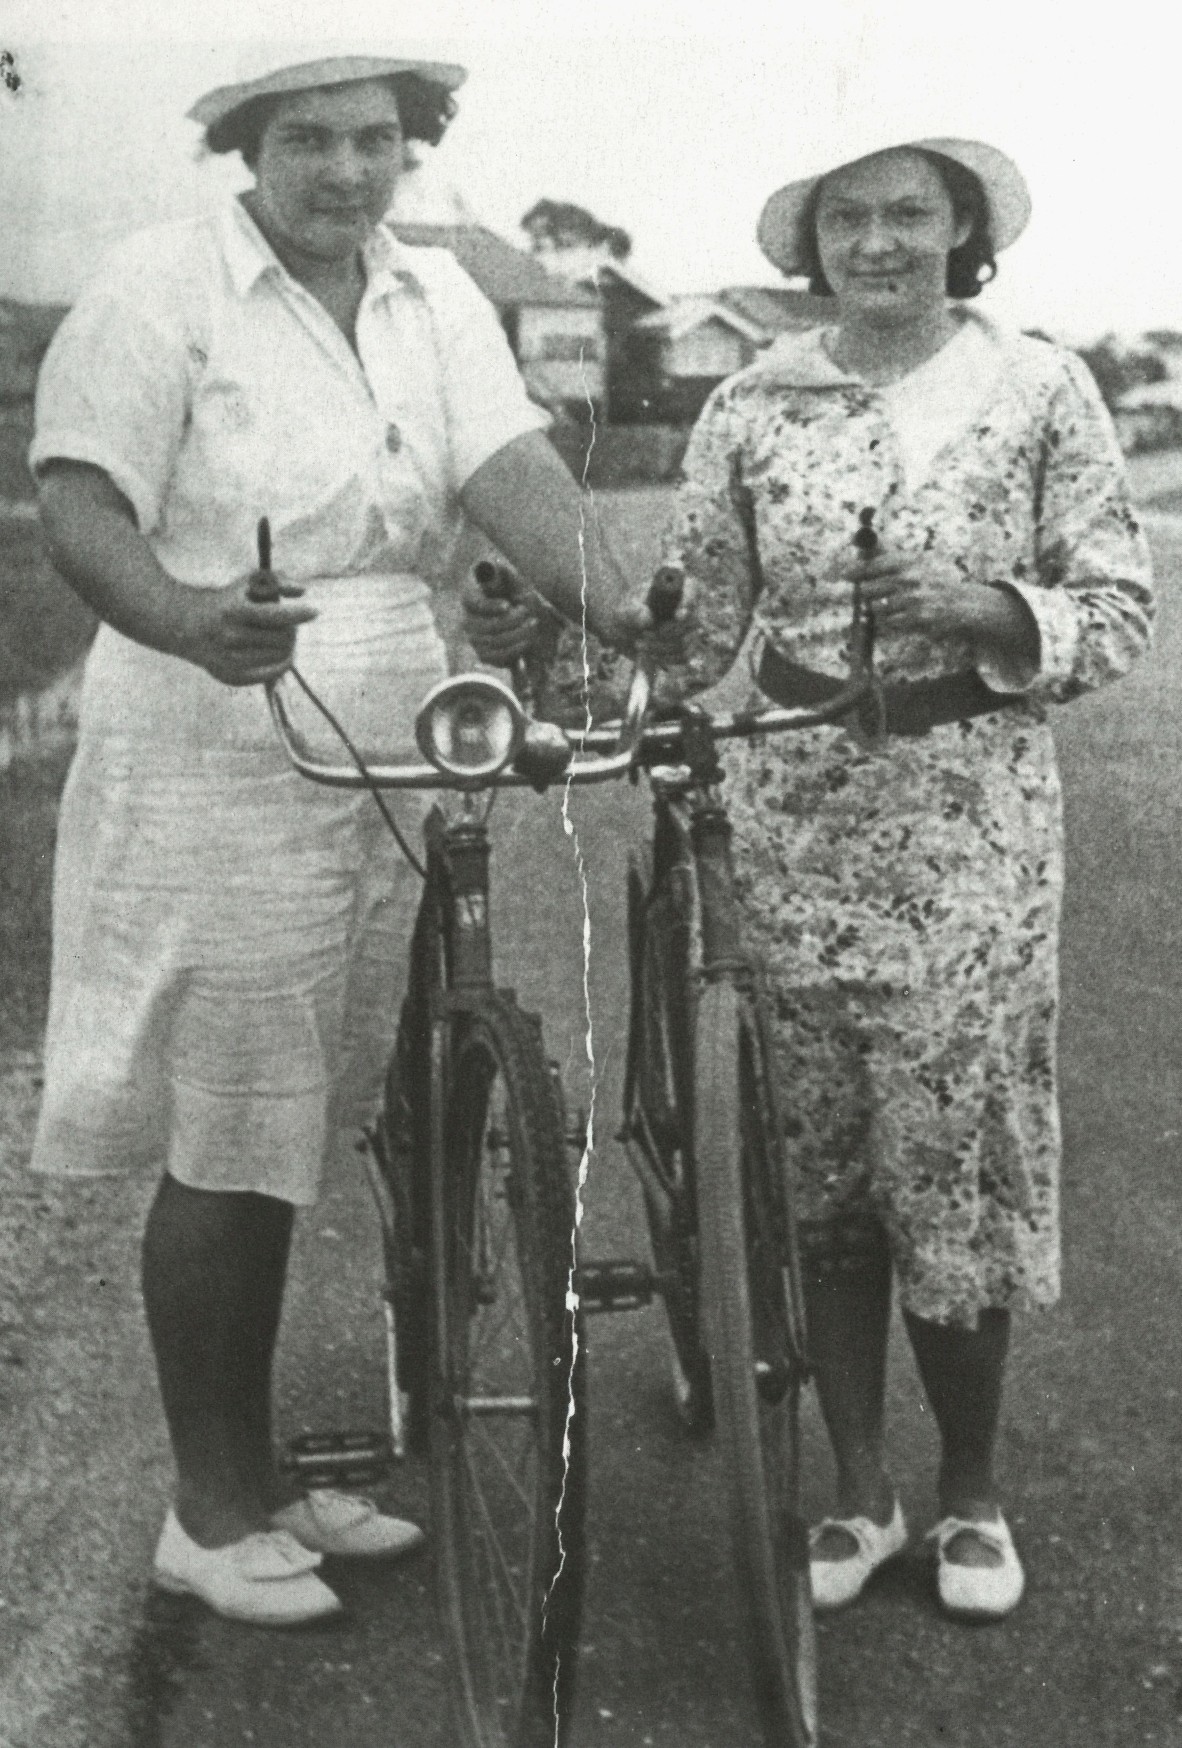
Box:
left=430, top=995, right=586, bottom=1748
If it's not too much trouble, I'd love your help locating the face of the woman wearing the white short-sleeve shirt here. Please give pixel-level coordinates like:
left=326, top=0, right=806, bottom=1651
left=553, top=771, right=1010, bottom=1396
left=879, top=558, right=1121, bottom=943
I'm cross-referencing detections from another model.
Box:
left=252, top=79, right=402, bottom=262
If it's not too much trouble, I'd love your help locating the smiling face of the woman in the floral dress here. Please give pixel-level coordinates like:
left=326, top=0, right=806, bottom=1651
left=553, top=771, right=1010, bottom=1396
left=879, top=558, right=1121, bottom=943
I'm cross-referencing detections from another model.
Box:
left=817, top=150, right=969, bottom=325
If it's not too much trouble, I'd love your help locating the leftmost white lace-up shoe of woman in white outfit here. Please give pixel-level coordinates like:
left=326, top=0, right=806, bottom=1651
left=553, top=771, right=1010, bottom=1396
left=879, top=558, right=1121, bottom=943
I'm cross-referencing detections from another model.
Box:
left=152, top=1510, right=341, bottom=1627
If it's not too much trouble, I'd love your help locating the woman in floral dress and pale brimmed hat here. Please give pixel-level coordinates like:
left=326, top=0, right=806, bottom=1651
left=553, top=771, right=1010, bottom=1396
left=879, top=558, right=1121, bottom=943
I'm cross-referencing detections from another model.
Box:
left=474, top=140, right=1152, bottom=1619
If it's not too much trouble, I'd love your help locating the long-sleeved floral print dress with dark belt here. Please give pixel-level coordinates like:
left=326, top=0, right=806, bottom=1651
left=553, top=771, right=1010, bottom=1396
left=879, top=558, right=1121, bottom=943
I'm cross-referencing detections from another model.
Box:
left=563, top=315, right=1152, bottom=1327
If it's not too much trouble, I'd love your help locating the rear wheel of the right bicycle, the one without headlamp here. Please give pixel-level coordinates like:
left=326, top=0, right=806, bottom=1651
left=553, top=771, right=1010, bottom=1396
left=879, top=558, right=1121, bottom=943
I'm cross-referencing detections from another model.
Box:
left=626, top=850, right=713, bottom=1435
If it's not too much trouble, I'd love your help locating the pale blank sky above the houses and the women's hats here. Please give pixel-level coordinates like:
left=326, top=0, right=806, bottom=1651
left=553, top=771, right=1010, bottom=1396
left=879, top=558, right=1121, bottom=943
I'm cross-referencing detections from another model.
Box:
left=0, top=0, right=1182, bottom=339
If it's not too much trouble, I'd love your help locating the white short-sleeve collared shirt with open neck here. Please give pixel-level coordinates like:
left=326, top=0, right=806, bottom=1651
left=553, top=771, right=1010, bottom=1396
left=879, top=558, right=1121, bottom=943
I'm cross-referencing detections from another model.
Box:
left=30, top=199, right=546, bottom=586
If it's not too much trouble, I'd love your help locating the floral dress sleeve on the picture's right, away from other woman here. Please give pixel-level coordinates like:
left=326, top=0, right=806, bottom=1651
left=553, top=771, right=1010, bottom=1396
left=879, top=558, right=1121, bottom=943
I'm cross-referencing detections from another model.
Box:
left=979, top=357, right=1154, bottom=703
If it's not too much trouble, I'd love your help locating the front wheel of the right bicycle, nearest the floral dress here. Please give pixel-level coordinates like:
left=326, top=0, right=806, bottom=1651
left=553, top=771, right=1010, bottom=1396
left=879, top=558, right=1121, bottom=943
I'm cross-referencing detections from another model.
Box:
left=694, top=977, right=817, bottom=1748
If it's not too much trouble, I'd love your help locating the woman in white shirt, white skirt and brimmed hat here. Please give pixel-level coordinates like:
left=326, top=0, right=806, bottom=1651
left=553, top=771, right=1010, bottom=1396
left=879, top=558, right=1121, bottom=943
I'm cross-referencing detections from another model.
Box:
left=31, top=56, right=628, bottom=1624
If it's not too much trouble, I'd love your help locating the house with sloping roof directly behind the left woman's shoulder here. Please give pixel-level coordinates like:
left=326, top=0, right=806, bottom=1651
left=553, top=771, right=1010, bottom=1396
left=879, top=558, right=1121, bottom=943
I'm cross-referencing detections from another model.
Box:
left=388, top=217, right=610, bottom=418
